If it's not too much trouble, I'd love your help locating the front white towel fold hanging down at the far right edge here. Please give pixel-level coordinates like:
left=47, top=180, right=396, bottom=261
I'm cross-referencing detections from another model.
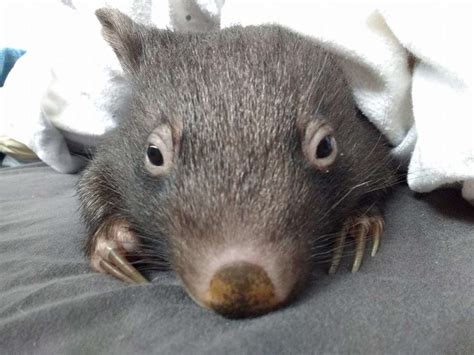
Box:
left=382, top=4, right=474, bottom=204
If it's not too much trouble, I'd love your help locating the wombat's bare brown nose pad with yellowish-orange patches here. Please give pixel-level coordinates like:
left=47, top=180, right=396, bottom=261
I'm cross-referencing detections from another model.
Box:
left=205, top=262, right=280, bottom=318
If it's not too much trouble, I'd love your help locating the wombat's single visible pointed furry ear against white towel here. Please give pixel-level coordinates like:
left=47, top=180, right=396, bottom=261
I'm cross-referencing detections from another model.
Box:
left=95, top=8, right=147, bottom=72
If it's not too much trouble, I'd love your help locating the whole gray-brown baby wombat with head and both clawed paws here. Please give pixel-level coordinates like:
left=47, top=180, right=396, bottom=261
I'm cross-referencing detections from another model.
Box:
left=78, top=9, right=395, bottom=317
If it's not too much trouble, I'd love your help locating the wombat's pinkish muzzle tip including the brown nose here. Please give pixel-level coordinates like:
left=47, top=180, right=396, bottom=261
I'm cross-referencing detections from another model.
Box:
left=178, top=245, right=307, bottom=318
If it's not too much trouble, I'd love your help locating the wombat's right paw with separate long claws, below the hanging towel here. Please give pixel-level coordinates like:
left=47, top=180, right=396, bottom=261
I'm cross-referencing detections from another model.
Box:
left=329, top=216, right=384, bottom=274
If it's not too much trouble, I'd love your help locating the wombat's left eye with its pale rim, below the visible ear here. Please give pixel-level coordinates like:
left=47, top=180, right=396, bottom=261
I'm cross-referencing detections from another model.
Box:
left=145, top=125, right=174, bottom=176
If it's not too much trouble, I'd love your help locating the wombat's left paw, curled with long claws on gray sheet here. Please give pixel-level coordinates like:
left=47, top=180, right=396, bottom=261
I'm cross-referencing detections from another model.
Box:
left=90, top=220, right=148, bottom=283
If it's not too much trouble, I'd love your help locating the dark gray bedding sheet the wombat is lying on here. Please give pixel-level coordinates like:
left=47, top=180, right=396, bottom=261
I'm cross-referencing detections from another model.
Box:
left=0, top=164, right=474, bottom=354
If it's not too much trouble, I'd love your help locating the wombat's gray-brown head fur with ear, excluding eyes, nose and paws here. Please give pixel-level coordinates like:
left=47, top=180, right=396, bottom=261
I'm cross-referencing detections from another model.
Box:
left=79, top=10, right=394, bottom=318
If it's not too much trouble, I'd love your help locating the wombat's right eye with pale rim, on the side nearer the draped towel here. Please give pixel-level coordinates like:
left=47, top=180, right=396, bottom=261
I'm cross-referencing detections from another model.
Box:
left=303, top=120, right=337, bottom=172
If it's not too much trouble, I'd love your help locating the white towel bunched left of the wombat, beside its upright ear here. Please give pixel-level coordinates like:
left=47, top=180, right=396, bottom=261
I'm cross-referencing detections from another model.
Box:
left=0, top=0, right=158, bottom=173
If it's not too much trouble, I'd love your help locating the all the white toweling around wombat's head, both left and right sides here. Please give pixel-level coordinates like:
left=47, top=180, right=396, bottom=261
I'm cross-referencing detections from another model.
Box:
left=0, top=0, right=474, bottom=203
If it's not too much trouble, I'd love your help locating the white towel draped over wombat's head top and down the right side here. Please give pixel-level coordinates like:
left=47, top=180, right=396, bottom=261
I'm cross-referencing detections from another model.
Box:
left=221, top=0, right=474, bottom=204
